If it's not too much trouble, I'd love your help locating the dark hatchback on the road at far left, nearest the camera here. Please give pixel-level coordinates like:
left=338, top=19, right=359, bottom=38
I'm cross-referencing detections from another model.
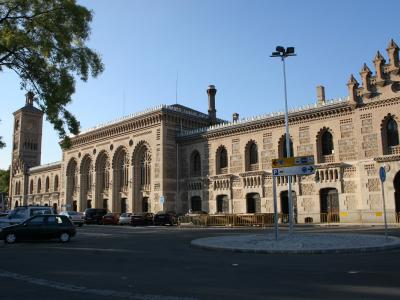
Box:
left=0, top=215, right=76, bottom=244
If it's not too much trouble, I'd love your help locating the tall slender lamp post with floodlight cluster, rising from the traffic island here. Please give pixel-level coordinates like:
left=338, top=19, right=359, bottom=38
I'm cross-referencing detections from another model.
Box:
left=271, top=46, right=296, bottom=234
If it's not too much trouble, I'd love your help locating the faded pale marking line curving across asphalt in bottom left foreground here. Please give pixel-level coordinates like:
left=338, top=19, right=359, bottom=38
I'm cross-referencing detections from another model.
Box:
left=0, top=269, right=195, bottom=300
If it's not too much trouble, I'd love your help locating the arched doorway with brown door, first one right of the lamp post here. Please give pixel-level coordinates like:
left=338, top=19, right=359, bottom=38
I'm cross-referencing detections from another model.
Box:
left=319, top=188, right=340, bottom=222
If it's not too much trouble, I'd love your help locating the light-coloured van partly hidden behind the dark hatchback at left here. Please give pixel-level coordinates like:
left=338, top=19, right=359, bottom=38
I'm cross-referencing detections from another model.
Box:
left=0, top=205, right=54, bottom=228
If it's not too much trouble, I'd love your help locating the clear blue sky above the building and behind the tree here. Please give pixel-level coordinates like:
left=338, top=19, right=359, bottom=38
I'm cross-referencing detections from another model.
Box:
left=0, top=0, right=400, bottom=169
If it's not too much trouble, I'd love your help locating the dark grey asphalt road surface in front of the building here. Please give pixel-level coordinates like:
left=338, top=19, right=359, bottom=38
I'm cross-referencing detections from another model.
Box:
left=0, top=225, right=400, bottom=300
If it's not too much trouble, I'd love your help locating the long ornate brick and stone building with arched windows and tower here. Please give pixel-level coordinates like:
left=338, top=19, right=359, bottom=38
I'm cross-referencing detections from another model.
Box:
left=10, top=40, right=400, bottom=222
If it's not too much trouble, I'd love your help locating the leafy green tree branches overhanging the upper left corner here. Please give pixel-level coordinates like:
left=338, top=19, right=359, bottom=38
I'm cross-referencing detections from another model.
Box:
left=0, top=0, right=104, bottom=147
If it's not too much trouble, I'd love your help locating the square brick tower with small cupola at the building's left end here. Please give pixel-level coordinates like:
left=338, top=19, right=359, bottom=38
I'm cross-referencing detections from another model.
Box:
left=11, top=92, right=43, bottom=175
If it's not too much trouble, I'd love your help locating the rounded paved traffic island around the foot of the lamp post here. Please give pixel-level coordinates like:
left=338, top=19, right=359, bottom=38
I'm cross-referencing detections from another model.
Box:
left=191, top=233, right=400, bottom=254
